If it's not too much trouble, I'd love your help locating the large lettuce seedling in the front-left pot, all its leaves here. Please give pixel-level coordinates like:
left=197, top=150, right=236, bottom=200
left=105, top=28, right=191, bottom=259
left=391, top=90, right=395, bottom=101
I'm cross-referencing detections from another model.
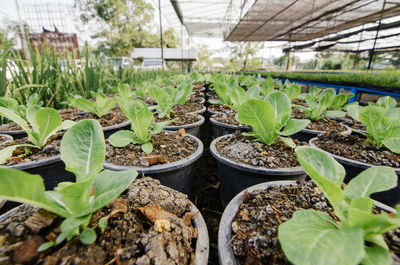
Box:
left=0, top=120, right=137, bottom=251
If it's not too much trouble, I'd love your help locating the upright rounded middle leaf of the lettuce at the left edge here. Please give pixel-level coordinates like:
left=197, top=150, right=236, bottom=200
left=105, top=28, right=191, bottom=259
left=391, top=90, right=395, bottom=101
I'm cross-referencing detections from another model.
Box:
left=35, top=108, right=61, bottom=147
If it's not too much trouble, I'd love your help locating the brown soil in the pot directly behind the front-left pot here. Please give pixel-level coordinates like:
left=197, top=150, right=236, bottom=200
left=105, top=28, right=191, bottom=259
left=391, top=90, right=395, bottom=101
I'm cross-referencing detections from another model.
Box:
left=106, top=131, right=197, bottom=166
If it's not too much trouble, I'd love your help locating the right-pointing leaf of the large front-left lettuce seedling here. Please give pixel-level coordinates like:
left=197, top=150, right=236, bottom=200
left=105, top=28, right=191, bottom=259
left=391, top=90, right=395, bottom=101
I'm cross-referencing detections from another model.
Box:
left=79, top=170, right=137, bottom=216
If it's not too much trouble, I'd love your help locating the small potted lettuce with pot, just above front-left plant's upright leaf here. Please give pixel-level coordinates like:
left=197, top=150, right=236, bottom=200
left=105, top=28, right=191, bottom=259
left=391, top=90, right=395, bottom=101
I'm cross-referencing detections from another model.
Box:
left=70, top=91, right=129, bottom=138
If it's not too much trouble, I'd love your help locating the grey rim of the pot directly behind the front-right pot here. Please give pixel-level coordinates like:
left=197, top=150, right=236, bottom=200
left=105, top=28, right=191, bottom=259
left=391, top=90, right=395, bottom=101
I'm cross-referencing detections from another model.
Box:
left=210, top=134, right=305, bottom=176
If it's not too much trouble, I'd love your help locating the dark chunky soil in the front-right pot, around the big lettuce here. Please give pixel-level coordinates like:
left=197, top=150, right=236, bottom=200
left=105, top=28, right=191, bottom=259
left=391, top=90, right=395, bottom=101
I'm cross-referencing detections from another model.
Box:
left=231, top=178, right=400, bottom=265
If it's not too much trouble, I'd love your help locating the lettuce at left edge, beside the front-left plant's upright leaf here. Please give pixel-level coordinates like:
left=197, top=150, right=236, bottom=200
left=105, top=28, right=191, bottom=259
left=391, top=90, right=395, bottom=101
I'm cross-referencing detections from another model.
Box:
left=0, top=105, right=75, bottom=164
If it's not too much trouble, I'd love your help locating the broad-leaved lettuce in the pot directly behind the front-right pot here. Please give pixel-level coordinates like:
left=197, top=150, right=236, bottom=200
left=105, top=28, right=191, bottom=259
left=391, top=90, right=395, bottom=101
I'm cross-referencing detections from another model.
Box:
left=238, top=91, right=310, bottom=147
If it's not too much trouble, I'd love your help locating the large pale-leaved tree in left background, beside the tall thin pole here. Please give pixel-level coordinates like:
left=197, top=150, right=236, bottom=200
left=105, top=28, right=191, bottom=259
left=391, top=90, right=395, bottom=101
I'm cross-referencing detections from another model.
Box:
left=75, top=0, right=179, bottom=56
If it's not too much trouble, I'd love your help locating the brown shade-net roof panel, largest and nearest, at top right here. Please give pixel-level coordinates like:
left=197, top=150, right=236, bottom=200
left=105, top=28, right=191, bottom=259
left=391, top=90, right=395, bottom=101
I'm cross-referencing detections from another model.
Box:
left=225, top=0, right=400, bottom=41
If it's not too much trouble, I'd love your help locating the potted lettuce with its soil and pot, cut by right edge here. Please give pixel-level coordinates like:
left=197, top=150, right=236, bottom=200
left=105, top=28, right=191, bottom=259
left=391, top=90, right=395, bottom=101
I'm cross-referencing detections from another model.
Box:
left=310, top=102, right=400, bottom=206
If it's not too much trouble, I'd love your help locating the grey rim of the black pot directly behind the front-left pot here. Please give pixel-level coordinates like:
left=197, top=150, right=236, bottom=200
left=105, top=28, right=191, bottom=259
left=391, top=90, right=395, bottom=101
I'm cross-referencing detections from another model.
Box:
left=103, top=131, right=204, bottom=174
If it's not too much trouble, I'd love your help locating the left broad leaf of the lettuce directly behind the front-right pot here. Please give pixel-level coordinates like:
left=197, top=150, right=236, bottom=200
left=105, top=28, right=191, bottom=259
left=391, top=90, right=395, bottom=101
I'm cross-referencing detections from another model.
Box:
left=238, top=99, right=278, bottom=144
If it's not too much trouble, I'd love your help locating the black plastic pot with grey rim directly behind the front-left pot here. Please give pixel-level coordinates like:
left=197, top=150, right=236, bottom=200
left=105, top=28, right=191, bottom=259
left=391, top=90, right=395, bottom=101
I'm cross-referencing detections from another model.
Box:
left=104, top=135, right=204, bottom=195
